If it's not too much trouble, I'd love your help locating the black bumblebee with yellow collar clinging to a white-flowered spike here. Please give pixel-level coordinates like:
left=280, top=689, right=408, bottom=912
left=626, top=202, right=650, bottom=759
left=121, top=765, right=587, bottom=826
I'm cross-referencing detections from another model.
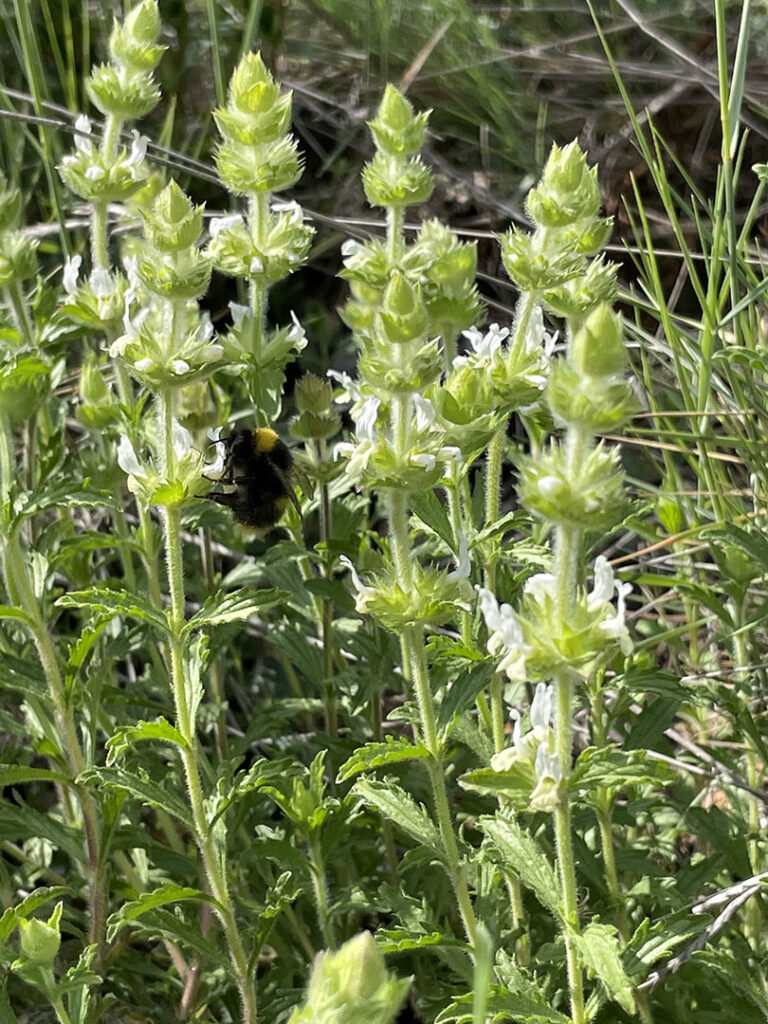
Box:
left=207, top=427, right=301, bottom=530
